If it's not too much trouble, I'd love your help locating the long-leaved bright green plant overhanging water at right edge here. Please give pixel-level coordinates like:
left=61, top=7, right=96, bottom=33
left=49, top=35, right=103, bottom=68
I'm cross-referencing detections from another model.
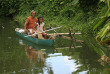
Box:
left=93, top=0, right=110, bottom=41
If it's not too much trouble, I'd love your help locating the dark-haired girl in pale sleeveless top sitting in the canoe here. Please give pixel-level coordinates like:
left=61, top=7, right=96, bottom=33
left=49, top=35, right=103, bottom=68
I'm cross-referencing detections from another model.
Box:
left=37, top=16, right=47, bottom=39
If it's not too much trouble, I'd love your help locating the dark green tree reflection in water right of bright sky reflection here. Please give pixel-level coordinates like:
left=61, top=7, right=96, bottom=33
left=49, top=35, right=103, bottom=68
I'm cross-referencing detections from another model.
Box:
left=73, top=36, right=109, bottom=74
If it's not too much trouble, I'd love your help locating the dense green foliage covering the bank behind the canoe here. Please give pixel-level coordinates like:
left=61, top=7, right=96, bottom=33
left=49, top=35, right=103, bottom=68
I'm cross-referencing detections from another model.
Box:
left=0, top=0, right=107, bottom=33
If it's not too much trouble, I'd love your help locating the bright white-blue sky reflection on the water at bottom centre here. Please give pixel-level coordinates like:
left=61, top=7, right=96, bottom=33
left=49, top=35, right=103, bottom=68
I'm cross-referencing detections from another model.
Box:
left=46, top=53, right=80, bottom=74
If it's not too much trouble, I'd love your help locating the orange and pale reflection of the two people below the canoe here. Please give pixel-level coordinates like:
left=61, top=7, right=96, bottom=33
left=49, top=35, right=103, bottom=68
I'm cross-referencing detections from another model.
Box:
left=25, top=45, right=46, bottom=64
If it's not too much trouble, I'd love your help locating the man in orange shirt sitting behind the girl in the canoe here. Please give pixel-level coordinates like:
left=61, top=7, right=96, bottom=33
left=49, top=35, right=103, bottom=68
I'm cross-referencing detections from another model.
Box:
left=24, top=10, right=38, bottom=34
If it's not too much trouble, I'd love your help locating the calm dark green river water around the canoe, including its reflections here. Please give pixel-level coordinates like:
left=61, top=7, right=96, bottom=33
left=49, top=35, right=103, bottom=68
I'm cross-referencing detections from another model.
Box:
left=0, top=18, right=110, bottom=74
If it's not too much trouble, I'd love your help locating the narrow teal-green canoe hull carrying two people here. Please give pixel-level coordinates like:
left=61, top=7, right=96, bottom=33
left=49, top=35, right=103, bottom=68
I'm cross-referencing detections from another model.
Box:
left=15, top=28, right=54, bottom=46
